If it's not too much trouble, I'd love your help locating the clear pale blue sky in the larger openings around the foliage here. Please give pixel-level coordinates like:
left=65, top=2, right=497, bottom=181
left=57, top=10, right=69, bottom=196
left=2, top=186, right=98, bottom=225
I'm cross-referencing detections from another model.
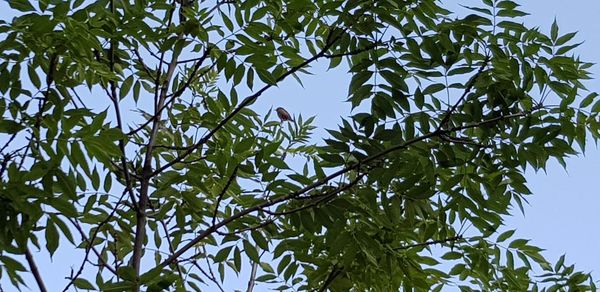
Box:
left=0, top=0, right=600, bottom=291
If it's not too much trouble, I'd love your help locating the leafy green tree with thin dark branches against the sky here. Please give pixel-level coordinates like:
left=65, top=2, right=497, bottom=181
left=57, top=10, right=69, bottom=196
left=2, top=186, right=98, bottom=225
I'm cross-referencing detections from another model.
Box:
left=0, top=0, right=600, bottom=291
